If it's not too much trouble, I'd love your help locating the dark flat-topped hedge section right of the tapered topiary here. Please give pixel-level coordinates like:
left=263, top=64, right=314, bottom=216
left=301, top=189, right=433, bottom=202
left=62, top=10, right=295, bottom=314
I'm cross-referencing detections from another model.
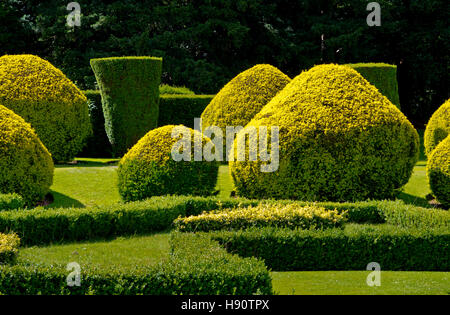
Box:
left=158, top=95, right=214, bottom=128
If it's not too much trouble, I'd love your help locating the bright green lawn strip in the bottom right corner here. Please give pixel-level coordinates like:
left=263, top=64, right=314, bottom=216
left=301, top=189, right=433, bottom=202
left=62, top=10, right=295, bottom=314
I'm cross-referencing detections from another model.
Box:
left=272, top=271, right=450, bottom=295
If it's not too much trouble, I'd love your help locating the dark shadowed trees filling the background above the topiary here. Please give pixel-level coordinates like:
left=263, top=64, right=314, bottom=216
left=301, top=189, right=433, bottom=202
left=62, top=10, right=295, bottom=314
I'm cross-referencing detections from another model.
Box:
left=0, top=0, right=450, bottom=126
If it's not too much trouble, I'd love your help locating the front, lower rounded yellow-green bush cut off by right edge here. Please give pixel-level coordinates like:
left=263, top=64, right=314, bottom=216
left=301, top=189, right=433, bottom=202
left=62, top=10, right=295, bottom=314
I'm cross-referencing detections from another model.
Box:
left=427, top=136, right=450, bottom=207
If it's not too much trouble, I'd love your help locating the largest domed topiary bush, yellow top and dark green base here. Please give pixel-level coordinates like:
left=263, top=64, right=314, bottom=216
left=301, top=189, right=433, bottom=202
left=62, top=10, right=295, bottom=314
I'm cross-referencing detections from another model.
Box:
left=230, top=64, right=419, bottom=201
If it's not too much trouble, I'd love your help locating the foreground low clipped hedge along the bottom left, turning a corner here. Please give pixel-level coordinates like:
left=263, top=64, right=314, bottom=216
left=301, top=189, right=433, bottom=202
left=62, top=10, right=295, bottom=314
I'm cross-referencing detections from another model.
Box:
left=0, top=234, right=272, bottom=295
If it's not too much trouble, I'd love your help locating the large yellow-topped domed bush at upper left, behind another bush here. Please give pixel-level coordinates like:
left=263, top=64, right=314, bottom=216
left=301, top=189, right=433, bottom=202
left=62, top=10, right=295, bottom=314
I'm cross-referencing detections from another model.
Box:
left=0, top=55, right=92, bottom=161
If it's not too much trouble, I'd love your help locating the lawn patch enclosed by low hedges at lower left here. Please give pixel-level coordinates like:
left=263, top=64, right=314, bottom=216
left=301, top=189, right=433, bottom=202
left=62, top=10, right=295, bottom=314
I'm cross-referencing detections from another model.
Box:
left=18, top=233, right=170, bottom=268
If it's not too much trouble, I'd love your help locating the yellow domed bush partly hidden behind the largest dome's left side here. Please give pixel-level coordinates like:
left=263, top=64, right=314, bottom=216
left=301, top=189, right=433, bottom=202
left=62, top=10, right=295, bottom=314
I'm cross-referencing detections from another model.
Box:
left=201, top=64, right=290, bottom=135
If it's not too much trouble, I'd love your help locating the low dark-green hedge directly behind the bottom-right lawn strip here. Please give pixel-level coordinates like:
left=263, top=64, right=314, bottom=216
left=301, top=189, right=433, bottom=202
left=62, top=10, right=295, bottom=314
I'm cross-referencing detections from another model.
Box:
left=209, top=225, right=450, bottom=271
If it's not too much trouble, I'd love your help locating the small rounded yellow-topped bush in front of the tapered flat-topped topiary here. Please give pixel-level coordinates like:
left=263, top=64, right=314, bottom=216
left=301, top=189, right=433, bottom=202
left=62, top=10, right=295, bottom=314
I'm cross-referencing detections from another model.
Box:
left=118, top=125, right=218, bottom=201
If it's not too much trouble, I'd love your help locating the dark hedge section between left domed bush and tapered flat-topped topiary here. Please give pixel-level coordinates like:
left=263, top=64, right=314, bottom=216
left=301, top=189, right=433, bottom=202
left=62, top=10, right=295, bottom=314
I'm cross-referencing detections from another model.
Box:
left=78, top=90, right=112, bottom=158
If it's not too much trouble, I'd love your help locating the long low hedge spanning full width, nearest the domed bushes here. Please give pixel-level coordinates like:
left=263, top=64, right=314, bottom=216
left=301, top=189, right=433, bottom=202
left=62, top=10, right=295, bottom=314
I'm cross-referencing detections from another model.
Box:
left=0, top=196, right=450, bottom=246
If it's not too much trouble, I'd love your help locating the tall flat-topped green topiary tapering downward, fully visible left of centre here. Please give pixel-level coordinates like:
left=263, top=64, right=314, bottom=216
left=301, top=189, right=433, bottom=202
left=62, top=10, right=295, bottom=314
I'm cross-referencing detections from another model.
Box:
left=91, top=57, right=162, bottom=156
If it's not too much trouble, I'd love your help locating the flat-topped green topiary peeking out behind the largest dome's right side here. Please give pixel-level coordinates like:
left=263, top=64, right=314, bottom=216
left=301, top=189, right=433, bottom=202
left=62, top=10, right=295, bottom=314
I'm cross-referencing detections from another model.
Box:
left=348, top=63, right=401, bottom=109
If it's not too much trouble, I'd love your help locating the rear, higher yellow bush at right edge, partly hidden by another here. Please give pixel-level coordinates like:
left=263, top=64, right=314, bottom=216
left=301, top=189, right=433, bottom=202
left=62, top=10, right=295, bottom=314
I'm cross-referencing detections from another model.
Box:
left=424, top=99, right=450, bottom=156
